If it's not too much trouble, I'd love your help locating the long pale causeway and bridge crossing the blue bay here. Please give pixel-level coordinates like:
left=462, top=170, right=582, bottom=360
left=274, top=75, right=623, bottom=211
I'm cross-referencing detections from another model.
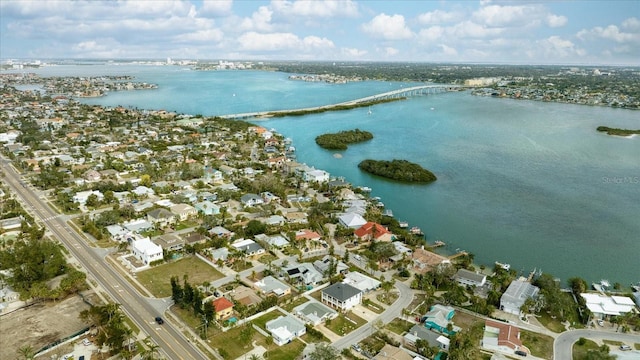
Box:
left=219, top=85, right=464, bottom=119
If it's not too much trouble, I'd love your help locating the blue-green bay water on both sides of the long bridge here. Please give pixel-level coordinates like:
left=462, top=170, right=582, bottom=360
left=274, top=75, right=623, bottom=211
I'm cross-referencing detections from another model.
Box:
left=20, top=66, right=640, bottom=284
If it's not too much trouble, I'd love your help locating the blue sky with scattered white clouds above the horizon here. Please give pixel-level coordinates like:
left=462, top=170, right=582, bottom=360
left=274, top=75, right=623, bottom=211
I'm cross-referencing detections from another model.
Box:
left=0, top=0, right=640, bottom=65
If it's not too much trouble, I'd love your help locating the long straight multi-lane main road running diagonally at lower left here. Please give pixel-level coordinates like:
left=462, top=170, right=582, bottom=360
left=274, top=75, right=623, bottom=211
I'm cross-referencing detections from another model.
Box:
left=0, top=156, right=209, bottom=359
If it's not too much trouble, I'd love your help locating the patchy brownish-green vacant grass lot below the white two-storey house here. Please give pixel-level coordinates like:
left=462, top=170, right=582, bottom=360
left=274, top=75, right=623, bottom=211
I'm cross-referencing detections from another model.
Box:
left=136, top=257, right=224, bottom=297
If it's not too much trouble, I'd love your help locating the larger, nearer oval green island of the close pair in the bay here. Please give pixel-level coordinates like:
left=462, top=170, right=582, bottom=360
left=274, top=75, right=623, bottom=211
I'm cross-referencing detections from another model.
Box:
left=358, top=160, right=438, bottom=183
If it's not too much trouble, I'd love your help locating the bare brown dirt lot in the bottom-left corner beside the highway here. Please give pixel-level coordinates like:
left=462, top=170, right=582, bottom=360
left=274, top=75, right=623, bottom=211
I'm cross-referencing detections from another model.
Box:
left=0, top=296, right=89, bottom=359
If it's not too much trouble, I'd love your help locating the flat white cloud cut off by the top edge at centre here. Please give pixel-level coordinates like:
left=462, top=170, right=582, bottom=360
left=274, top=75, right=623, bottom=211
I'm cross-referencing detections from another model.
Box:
left=271, top=0, right=358, bottom=18
